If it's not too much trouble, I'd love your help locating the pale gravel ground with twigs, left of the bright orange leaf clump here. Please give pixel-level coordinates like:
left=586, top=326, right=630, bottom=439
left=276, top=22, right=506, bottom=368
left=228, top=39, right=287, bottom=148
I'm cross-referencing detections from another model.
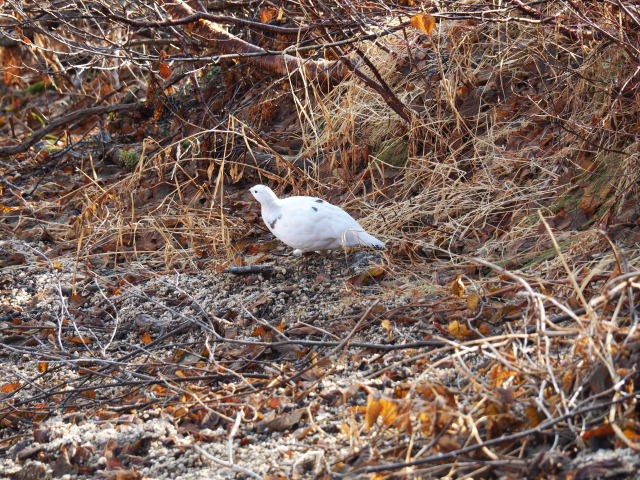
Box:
left=0, top=240, right=459, bottom=479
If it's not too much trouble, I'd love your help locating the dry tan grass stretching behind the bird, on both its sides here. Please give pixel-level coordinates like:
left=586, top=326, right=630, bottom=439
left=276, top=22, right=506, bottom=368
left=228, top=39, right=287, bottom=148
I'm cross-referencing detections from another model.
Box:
left=45, top=2, right=640, bottom=278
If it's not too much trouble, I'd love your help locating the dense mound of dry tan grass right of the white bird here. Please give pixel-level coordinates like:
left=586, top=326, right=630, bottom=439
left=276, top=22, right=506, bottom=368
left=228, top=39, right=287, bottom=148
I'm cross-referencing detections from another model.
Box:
left=296, top=7, right=640, bottom=274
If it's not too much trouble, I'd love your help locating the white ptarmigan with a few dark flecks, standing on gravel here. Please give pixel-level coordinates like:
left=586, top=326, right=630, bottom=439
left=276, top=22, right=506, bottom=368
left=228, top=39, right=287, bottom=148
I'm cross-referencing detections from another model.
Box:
left=250, top=185, right=384, bottom=255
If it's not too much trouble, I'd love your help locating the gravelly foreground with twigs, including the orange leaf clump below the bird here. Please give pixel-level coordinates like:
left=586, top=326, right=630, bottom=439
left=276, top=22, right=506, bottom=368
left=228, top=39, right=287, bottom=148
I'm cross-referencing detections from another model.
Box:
left=0, top=234, right=640, bottom=480
